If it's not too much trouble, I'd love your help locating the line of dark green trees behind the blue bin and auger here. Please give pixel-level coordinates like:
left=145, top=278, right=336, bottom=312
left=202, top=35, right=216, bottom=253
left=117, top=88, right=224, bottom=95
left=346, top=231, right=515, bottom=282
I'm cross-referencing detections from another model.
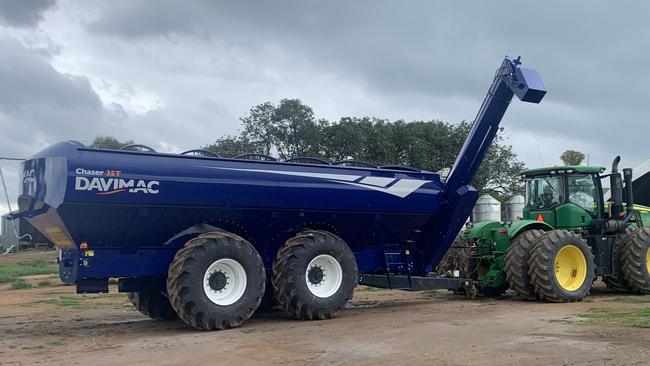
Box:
left=91, top=99, right=525, bottom=200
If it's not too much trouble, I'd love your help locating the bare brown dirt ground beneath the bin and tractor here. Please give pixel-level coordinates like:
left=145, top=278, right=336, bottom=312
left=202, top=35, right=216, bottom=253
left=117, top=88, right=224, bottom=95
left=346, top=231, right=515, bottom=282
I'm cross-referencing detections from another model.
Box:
left=0, top=252, right=650, bottom=366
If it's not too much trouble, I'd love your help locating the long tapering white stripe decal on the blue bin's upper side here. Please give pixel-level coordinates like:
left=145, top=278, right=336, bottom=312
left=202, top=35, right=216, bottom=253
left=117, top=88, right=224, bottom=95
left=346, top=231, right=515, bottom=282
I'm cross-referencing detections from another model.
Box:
left=201, top=165, right=431, bottom=198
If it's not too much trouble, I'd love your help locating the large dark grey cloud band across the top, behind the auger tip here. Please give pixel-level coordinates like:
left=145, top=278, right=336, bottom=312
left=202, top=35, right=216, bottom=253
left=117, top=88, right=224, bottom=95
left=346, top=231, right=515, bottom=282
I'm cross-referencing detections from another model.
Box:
left=82, top=0, right=650, bottom=113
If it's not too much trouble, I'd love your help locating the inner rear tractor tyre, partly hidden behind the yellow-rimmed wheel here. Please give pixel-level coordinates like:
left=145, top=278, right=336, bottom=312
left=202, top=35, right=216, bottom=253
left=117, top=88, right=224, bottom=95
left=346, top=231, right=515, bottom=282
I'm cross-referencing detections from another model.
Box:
left=505, top=229, right=546, bottom=300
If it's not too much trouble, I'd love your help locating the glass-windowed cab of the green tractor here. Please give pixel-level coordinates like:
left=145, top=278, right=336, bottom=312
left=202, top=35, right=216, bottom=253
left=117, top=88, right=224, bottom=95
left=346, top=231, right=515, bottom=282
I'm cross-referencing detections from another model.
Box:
left=522, top=166, right=607, bottom=229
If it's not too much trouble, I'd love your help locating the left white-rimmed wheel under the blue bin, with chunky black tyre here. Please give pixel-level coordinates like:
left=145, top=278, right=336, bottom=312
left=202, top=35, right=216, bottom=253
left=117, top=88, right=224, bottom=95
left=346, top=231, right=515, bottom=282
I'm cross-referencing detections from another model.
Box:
left=167, top=232, right=266, bottom=330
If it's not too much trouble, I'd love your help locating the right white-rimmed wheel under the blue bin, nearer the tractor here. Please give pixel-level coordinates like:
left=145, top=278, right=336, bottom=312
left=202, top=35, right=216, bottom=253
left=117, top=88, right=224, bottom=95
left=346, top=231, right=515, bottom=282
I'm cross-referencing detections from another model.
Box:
left=273, top=230, right=358, bottom=320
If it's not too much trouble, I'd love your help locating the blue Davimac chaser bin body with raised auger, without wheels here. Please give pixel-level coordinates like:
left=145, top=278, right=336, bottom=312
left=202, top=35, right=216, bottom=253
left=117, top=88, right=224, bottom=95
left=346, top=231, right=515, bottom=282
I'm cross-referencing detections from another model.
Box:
left=13, top=57, right=546, bottom=292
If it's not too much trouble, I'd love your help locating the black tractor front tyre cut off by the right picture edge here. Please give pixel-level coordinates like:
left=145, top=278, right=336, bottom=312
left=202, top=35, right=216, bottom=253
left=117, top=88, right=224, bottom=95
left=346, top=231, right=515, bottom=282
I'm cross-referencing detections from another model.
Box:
left=621, top=228, right=650, bottom=294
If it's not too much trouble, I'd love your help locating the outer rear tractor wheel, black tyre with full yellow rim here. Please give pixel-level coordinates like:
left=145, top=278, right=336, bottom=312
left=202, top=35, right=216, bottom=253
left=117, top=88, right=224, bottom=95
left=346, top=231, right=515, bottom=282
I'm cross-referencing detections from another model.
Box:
left=528, top=230, right=595, bottom=302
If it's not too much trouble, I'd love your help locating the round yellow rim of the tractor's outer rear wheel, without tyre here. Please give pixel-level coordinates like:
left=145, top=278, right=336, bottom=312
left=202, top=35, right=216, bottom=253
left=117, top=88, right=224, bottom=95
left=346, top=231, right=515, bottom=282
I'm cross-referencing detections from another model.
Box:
left=555, top=245, right=588, bottom=291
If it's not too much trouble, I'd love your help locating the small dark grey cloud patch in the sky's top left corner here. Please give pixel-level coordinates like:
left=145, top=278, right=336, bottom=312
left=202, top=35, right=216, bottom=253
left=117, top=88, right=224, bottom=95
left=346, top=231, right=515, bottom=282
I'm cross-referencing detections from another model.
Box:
left=0, top=0, right=56, bottom=27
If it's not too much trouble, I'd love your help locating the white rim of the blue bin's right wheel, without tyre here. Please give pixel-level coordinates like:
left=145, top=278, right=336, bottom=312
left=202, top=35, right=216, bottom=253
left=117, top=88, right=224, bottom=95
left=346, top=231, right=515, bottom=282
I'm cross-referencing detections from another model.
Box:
left=305, top=254, right=343, bottom=298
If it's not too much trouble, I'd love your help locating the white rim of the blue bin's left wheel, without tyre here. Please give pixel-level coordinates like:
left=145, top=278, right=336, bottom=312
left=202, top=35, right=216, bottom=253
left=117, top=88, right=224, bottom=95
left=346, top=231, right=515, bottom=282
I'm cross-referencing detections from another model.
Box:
left=203, top=258, right=247, bottom=306
